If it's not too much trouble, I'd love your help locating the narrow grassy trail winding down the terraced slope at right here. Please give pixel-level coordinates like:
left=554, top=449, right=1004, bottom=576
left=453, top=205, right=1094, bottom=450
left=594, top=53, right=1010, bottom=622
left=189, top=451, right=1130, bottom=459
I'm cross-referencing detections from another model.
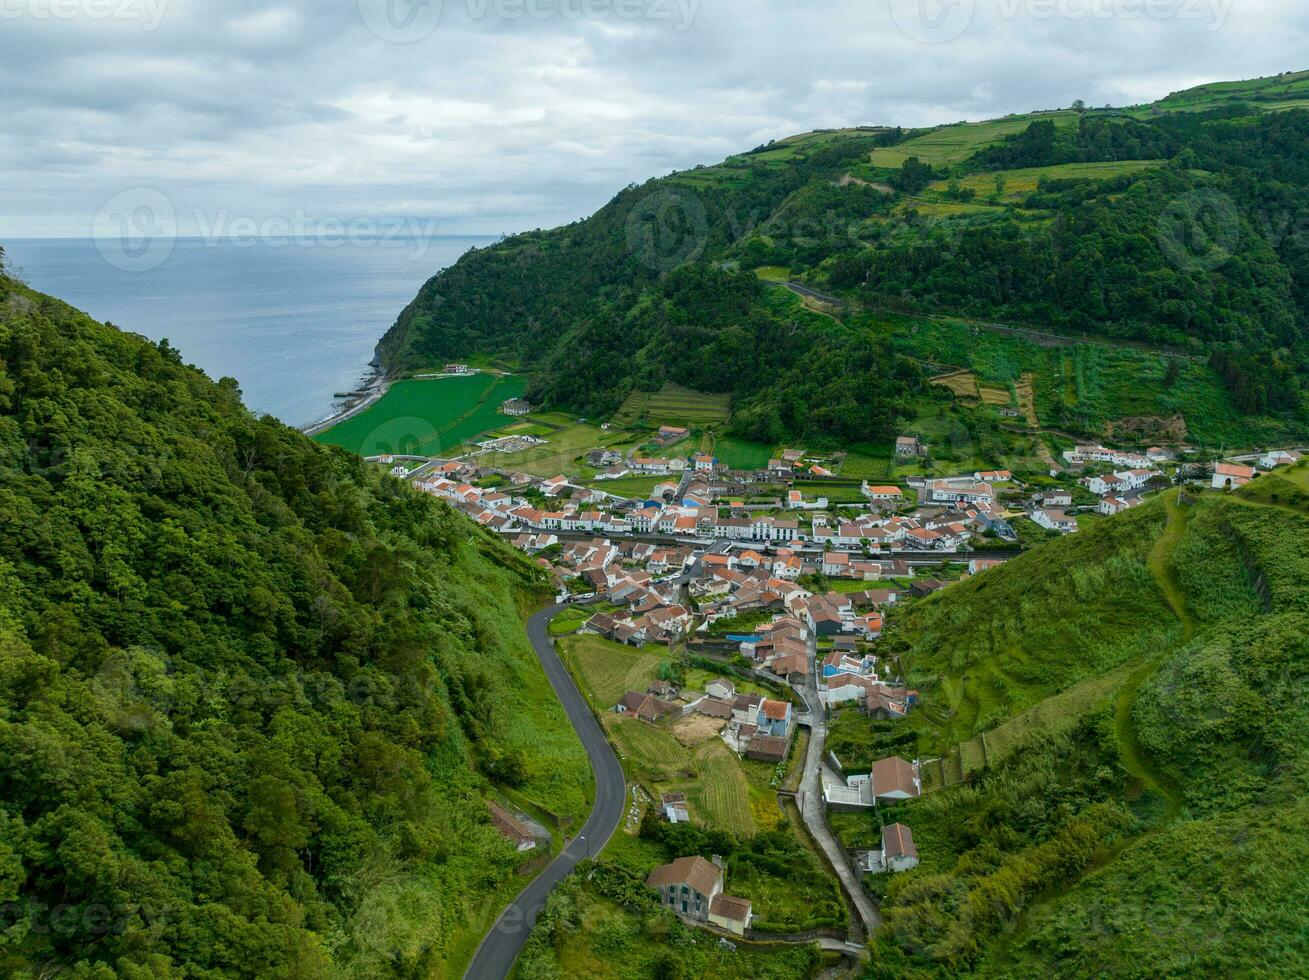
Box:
left=1114, top=492, right=1195, bottom=827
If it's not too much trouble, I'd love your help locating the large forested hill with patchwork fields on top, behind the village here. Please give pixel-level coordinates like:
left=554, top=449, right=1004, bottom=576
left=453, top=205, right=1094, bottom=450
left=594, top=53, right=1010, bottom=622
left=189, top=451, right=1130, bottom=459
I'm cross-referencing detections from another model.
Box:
left=378, top=73, right=1309, bottom=445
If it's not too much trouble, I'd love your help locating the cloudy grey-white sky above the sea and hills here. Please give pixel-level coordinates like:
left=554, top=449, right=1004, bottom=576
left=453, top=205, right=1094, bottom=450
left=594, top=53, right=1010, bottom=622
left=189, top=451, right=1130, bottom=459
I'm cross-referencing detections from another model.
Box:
left=0, top=0, right=1309, bottom=239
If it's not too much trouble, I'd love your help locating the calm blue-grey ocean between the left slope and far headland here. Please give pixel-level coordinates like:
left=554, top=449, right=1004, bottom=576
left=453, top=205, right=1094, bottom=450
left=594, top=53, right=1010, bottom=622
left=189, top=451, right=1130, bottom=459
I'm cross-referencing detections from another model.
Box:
left=0, top=236, right=495, bottom=425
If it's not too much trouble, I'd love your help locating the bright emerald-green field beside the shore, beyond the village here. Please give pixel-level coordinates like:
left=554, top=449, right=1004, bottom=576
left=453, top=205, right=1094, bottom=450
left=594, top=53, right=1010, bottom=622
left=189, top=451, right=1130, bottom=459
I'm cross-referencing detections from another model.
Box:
left=314, top=374, right=528, bottom=457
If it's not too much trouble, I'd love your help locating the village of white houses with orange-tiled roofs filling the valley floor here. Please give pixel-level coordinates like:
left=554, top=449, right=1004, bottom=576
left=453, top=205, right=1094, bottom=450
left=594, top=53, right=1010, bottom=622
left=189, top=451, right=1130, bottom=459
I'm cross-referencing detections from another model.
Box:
left=376, top=400, right=1300, bottom=937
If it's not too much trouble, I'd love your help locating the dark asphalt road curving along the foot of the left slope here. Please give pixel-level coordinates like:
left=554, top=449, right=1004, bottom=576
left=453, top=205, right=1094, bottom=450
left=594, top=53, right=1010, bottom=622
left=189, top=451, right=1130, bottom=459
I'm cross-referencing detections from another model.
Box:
left=463, top=606, right=627, bottom=980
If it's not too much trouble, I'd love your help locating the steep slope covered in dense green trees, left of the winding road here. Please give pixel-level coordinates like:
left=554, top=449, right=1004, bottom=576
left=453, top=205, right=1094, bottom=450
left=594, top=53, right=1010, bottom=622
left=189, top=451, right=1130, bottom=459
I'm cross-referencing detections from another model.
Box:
left=0, top=264, right=592, bottom=977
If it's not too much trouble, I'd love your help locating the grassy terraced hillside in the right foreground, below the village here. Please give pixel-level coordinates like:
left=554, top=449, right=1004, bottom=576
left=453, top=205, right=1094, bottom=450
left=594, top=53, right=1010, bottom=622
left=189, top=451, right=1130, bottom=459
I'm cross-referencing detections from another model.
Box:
left=853, top=478, right=1309, bottom=977
